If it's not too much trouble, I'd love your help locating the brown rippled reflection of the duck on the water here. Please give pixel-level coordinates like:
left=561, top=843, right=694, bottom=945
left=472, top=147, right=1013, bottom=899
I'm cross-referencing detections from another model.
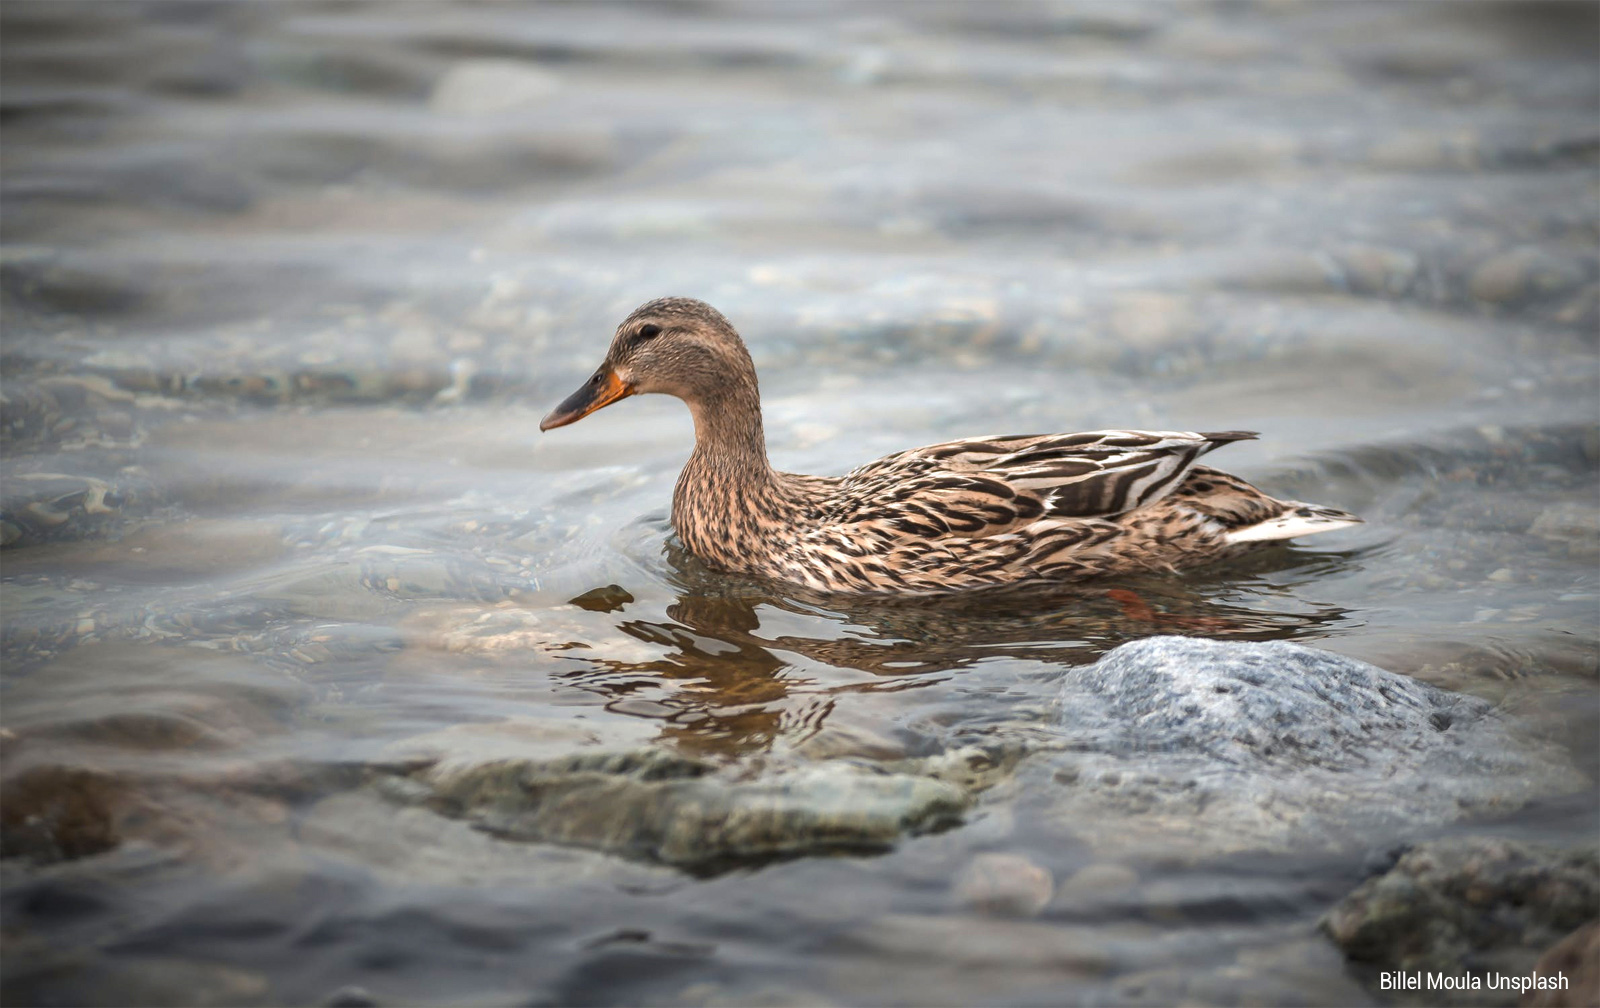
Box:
left=553, top=539, right=1355, bottom=757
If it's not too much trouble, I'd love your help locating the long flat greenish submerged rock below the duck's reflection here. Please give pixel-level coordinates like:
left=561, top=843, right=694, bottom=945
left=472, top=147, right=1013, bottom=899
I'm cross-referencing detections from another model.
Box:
left=390, top=747, right=970, bottom=869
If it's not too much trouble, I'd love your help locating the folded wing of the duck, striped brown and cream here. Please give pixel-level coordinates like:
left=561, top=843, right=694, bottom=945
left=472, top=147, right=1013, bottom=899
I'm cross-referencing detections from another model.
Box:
left=829, top=430, right=1256, bottom=538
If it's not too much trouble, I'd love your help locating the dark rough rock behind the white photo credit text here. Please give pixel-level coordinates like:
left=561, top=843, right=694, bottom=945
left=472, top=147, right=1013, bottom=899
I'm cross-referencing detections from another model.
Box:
left=1323, top=837, right=1600, bottom=1005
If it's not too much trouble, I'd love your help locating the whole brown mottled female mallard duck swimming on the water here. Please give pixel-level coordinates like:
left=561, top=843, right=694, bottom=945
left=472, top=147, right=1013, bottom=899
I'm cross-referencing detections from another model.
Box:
left=539, top=298, right=1360, bottom=594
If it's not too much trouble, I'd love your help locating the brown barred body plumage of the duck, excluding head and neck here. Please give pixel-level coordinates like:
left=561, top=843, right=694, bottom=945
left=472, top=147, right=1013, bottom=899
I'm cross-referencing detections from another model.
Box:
left=675, top=430, right=1358, bottom=594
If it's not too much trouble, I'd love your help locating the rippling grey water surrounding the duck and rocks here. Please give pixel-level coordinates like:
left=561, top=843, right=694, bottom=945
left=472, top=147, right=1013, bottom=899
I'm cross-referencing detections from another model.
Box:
left=0, top=2, right=1600, bottom=1005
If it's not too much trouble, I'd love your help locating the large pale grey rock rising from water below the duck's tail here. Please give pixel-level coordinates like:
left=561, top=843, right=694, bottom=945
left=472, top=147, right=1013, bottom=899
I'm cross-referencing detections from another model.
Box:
left=1053, top=637, right=1584, bottom=856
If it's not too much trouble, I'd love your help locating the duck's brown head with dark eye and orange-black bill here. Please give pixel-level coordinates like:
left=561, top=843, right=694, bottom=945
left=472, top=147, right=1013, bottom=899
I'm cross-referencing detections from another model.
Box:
left=539, top=298, right=755, bottom=430
